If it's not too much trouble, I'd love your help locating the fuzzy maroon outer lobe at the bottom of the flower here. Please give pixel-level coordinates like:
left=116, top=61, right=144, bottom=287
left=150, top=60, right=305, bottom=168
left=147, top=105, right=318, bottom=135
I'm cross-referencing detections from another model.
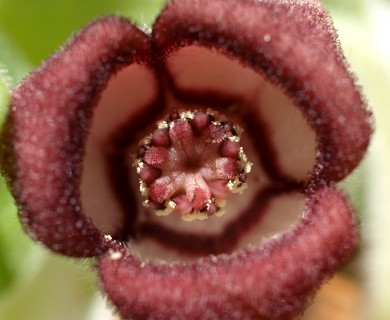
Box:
left=99, top=188, right=358, bottom=320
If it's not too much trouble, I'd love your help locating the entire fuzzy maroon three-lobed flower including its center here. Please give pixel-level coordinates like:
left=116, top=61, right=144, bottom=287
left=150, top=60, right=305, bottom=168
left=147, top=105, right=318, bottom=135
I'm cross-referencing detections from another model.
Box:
left=1, top=0, right=372, bottom=319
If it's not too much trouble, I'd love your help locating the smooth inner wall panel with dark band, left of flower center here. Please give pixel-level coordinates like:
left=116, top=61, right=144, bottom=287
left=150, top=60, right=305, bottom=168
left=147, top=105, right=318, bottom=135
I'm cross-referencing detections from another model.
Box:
left=81, top=63, right=163, bottom=237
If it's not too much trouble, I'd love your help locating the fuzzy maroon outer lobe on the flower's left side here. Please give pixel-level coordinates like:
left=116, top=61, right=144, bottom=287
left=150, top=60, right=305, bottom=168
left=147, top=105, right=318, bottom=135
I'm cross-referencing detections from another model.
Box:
left=1, top=17, right=154, bottom=256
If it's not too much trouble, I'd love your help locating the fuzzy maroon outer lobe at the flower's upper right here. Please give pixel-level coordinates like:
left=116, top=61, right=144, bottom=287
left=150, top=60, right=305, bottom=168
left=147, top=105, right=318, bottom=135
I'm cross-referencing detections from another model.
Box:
left=153, top=0, right=372, bottom=181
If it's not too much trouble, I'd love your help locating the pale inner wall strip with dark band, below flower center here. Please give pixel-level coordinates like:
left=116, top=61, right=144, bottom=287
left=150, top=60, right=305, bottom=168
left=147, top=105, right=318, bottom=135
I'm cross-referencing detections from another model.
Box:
left=133, top=186, right=305, bottom=262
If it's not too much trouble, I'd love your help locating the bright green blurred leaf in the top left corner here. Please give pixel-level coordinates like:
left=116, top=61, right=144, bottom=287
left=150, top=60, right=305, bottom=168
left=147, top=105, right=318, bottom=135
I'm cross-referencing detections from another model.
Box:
left=0, top=0, right=164, bottom=65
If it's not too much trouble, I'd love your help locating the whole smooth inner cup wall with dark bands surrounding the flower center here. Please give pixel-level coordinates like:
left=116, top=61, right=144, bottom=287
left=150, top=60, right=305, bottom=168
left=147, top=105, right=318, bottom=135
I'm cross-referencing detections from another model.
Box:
left=81, top=46, right=316, bottom=261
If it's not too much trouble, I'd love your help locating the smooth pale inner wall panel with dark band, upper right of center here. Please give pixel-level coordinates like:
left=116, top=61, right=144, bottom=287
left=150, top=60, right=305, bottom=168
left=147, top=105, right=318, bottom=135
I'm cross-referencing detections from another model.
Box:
left=160, top=45, right=316, bottom=181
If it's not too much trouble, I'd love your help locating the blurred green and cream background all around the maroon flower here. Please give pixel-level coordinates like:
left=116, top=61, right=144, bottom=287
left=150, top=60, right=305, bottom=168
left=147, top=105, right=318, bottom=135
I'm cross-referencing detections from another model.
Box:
left=0, top=0, right=390, bottom=320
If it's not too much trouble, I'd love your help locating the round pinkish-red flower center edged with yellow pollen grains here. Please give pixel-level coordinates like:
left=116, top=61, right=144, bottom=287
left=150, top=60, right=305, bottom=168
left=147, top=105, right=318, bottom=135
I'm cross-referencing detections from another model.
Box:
left=135, top=110, right=252, bottom=221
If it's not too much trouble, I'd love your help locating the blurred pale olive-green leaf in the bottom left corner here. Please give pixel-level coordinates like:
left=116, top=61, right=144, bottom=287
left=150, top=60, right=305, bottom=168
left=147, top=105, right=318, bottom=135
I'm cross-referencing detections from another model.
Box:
left=0, top=251, right=97, bottom=320
